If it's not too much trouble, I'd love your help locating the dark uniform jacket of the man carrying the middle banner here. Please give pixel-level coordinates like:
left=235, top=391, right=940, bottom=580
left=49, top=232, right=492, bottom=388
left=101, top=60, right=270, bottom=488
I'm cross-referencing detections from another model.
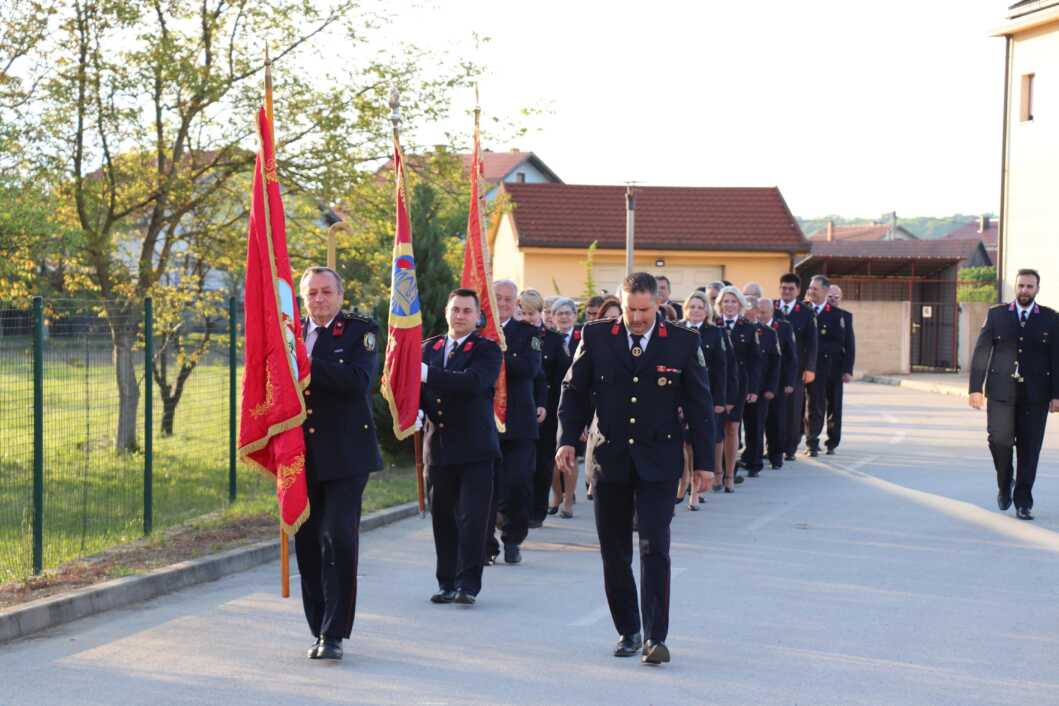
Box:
left=420, top=332, right=502, bottom=466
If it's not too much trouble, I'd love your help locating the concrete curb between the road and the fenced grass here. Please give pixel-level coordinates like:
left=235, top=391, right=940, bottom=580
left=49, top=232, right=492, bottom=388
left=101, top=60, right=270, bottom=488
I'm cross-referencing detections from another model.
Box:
left=0, top=503, right=419, bottom=644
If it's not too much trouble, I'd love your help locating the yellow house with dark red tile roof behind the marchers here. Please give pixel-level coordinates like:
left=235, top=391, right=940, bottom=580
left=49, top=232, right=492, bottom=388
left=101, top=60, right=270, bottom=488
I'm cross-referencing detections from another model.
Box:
left=490, top=182, right=809, bottom=301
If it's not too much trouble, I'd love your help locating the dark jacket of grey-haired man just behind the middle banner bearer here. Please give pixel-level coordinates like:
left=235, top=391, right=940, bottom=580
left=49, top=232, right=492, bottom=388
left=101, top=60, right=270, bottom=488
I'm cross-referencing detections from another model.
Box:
left=501, top=319, right=541, bottom=439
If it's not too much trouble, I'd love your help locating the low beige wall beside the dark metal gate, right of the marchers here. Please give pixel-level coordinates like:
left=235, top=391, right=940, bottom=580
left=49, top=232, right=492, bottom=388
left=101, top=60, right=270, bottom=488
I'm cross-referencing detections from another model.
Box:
left=842, top=300, right=912, bottom=376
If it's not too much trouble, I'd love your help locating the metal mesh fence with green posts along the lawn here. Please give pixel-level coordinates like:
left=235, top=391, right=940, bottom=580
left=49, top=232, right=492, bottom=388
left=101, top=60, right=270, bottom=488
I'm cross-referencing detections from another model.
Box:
left=0, top=300, right=273, bottom=583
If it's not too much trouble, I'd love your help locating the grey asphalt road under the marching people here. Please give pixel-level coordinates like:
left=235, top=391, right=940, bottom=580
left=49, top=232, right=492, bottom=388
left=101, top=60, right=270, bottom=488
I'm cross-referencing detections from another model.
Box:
left=0, top=384, right=1059, bottom=706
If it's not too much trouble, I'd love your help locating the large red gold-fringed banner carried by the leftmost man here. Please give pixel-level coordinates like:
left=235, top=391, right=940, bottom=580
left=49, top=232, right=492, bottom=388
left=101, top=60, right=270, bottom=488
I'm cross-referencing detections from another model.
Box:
left=239, top=103, right=311, bottom=535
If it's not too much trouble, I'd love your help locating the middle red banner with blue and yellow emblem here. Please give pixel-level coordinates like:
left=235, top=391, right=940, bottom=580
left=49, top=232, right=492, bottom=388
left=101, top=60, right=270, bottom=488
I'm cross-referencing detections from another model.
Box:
left=380, top=131, right=423, bottom=439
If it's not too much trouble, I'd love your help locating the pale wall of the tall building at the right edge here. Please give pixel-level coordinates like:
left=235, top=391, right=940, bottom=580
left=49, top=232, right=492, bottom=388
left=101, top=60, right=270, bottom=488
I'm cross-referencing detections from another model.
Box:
left=999, top=22, right=1059, bottom=306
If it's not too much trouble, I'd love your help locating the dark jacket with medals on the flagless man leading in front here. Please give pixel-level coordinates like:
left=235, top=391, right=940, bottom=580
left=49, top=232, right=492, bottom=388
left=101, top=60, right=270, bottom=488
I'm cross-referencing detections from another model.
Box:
left=559, top=319, right=714, bottom=483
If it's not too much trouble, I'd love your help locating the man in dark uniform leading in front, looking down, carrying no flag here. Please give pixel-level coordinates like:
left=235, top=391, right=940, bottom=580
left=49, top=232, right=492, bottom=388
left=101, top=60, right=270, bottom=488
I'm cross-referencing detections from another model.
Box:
left=556, top=272, right=714, bottom=665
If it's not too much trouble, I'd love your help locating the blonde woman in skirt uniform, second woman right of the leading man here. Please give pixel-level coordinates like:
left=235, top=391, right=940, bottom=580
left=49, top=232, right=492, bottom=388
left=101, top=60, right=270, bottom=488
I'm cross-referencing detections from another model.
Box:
left=715, top=287, right=761, bottom=493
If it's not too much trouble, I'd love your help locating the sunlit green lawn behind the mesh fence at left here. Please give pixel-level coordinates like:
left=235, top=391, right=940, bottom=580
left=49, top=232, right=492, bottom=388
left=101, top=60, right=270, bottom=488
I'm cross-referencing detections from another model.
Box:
left=0, top=340, right=415, bottom=583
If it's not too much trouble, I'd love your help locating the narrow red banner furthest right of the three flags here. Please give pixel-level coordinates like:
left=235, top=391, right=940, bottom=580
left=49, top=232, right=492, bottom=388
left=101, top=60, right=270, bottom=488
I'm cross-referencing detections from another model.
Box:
left=460, top=109, right=507, bottom=432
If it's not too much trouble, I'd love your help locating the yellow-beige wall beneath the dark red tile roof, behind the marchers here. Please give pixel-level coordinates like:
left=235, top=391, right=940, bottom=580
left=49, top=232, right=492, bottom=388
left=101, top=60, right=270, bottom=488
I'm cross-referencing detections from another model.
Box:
left=492, top=215, right=790, bottom=301
